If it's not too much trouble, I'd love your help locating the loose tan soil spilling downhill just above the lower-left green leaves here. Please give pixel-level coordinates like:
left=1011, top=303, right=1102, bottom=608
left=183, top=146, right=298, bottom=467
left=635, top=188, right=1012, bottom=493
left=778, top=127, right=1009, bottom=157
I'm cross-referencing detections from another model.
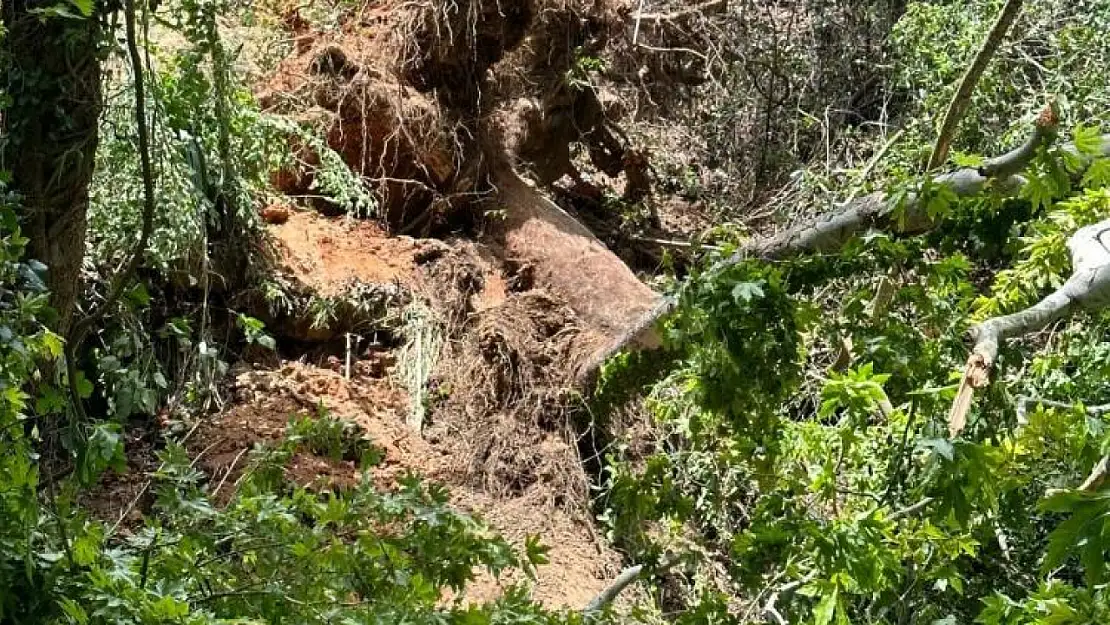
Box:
left=189, top=359, right=620, bottom=607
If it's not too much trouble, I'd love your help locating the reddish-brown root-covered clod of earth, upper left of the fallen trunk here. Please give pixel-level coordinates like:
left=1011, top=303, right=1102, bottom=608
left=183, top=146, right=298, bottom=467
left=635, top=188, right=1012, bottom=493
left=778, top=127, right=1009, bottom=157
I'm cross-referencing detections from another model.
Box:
left=256, top=27, right=459, bottom=230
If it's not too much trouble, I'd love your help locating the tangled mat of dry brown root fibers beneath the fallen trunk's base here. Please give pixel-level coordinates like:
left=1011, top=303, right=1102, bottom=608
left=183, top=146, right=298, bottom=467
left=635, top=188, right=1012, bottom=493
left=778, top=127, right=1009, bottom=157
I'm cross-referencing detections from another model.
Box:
left=427, top=291, right=587, bottom=505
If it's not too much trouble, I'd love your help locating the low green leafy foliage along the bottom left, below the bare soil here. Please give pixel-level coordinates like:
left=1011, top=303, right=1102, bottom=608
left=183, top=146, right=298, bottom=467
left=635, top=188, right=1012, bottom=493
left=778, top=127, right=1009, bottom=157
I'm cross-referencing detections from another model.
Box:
left=0, top=388, right=599, bottom=625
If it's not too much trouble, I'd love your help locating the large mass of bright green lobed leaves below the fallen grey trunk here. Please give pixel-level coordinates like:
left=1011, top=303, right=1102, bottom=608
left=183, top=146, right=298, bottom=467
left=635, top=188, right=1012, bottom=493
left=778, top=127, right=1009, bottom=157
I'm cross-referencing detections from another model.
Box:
left=601, top=107, right=1110, bottom=625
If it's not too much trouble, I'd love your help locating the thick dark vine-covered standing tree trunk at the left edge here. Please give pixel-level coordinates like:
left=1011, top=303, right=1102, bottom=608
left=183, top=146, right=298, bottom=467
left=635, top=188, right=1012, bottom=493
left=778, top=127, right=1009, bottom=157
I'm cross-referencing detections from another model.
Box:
left=3, top=6, right=101, bottom=335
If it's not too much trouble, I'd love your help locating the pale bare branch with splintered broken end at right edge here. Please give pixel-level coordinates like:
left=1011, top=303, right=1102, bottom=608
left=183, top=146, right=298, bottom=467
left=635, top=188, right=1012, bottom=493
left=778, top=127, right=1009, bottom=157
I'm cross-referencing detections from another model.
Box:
left=948, top=220, right=1110, bottom=437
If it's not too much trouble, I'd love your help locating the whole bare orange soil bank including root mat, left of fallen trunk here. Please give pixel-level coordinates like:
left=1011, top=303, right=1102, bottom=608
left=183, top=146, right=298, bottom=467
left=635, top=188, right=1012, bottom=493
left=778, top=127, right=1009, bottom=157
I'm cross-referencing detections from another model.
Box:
left=196, top=212, right=620, bottom=608
